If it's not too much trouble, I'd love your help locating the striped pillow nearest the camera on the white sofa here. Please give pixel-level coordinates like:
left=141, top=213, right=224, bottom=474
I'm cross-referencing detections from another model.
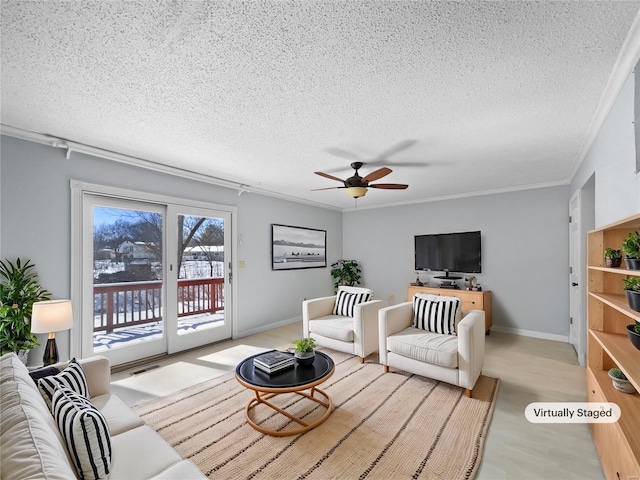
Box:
left=52, top=386, right=111, bottom=479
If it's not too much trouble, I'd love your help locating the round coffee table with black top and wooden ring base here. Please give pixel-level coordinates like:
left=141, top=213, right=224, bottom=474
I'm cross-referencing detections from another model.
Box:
left=236, top=352, right=335, bottom=437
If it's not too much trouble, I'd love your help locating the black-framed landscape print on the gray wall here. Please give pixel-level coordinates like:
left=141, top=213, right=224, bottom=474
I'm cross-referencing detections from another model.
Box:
left=271, top=223, right=327, bottom=270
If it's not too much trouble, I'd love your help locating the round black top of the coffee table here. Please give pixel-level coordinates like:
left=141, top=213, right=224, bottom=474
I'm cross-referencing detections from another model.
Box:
left=236, top=351, right=334, bottom=388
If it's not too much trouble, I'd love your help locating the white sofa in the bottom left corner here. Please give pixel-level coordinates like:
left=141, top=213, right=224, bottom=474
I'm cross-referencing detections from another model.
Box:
left=0, top=353, right=205, bottom=480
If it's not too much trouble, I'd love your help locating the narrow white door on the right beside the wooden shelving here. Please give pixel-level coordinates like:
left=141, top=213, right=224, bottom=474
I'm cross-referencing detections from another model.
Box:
left=569, top=190, right=584, bottom=364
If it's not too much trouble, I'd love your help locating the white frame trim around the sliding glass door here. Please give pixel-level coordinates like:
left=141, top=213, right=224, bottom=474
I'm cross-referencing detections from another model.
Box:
left=69, top=179, right=238, bottom=358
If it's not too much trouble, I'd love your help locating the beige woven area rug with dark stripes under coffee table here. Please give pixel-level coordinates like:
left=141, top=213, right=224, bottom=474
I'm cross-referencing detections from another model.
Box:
left=134, top=350, right=498, bottom=480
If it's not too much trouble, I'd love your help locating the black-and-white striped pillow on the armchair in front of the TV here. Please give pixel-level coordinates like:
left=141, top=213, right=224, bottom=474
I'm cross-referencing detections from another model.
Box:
left=413, top=295, right=461, bottom=335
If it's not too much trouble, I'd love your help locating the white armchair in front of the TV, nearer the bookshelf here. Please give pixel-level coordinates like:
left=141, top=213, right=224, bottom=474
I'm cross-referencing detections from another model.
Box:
left=378, top=302, right=485, bottom=397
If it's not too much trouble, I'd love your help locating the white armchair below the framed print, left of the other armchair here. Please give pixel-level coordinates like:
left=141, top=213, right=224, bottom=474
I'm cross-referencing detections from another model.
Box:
left=302, top=287, right=388, bottom=363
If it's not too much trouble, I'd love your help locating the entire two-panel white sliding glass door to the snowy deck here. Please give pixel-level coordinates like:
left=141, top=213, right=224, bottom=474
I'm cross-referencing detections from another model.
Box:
left=76, top=190, right=232, bottom=365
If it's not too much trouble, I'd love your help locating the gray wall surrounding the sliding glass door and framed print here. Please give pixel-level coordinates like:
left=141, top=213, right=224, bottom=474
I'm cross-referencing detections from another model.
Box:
left=0, top=136, right=342, bottom=361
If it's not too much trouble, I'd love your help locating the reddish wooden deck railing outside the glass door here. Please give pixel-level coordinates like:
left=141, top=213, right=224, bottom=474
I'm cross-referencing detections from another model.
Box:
left=93, top=278, right=224, bottom=333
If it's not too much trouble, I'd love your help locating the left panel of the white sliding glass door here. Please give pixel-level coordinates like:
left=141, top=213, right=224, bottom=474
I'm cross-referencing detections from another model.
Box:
left=82, top=196, right=167, bottom=365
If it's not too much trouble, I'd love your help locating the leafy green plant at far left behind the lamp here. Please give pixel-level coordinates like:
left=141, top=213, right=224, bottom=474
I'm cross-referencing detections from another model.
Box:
left=0, top=258, right=51, bottom=364
